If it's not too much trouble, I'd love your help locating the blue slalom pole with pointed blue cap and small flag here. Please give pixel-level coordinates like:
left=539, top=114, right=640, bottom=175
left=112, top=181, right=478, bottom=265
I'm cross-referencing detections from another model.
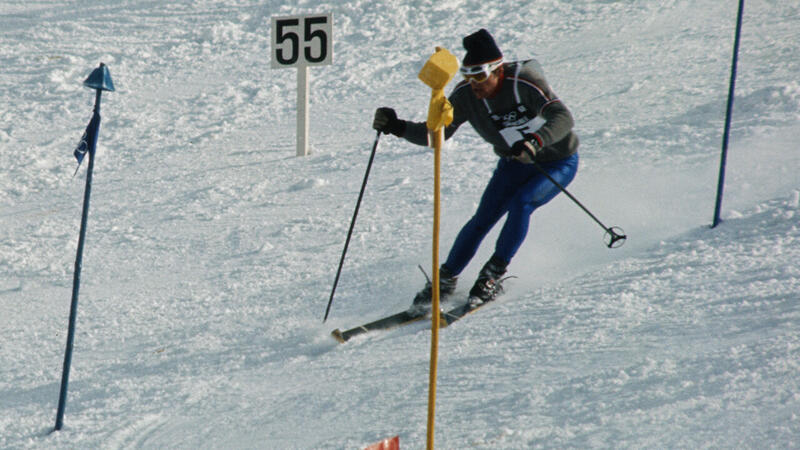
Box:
left=53, top=63, right=114, bottom=431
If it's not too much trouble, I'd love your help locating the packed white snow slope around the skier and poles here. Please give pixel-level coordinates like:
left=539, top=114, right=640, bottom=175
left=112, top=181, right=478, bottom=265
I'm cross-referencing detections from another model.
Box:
left=0, top=0, right=800, bottom=449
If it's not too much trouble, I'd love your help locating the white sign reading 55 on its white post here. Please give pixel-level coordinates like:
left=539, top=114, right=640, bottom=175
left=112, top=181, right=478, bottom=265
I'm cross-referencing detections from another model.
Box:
left=272, top=13, right=333, bottom=156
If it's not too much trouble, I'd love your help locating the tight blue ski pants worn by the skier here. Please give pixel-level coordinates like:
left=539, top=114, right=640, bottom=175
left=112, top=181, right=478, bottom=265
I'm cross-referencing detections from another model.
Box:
left=444, top=153, right=578, bottom=275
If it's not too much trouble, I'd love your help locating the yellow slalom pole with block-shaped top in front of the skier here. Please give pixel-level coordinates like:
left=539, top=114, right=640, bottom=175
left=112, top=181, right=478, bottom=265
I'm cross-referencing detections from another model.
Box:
left=419, top=47, right=458, bottom=450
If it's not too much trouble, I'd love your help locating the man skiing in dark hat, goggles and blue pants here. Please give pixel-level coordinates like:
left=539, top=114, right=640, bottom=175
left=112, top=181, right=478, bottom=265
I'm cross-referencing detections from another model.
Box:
left=372, top=29, right=578, bottom=307
